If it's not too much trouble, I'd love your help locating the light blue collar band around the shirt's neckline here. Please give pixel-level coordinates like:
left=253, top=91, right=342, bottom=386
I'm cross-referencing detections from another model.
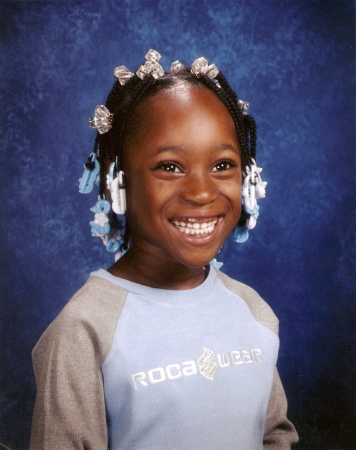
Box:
left=90, top=265, right=216, bottom=303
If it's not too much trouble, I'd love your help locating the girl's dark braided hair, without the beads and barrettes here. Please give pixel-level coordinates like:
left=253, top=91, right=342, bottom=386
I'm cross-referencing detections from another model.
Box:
left=94, top=68, right=256, bottom=248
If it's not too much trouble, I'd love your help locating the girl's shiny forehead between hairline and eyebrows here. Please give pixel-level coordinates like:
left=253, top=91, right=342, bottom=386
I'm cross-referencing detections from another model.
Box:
left=125, top=83, right=238, bottom=154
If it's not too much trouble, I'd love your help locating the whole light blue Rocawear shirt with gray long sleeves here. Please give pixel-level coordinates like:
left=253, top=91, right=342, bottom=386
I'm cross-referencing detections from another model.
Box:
left=31, top=267, right=298, bottom=450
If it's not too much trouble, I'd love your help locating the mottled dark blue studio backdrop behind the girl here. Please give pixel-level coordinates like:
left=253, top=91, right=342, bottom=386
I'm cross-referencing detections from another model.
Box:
left=0, top=0, right=356, bottom=450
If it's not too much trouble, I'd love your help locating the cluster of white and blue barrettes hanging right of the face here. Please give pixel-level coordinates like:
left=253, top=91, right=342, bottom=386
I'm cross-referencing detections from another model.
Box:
left=233, top=158, right=267, bottom=243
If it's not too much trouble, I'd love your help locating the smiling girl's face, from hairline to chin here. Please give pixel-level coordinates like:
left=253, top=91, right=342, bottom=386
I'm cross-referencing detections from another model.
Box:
left=123, top=84, right=242, bottom=267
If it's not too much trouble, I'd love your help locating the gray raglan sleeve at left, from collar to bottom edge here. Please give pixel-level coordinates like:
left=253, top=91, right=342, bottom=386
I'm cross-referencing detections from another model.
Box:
left=30, top=277, right=126, bottom=450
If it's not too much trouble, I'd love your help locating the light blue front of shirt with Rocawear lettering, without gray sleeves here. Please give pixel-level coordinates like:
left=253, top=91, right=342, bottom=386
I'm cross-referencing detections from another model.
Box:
left=91, top=267, right=279, bottom=450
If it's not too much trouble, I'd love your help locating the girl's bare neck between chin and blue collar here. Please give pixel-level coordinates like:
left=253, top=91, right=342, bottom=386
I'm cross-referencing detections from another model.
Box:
left=108, top=246, right=205, bottom=290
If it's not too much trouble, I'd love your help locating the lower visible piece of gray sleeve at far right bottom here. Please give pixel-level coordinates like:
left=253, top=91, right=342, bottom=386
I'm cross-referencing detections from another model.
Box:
left=263, top=369, right=299, bottom=450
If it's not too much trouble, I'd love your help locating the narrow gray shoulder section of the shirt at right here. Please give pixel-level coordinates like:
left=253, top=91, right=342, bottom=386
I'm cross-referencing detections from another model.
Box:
left=217, top=271, right=279, bottom=335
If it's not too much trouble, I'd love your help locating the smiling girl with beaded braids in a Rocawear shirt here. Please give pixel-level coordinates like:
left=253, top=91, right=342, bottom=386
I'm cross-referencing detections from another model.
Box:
left=31, top=50, right=297, bottom=450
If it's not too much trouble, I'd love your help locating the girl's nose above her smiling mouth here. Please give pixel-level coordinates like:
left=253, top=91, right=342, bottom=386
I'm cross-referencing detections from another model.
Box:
left=180, top=171, right=217, bottom=205
